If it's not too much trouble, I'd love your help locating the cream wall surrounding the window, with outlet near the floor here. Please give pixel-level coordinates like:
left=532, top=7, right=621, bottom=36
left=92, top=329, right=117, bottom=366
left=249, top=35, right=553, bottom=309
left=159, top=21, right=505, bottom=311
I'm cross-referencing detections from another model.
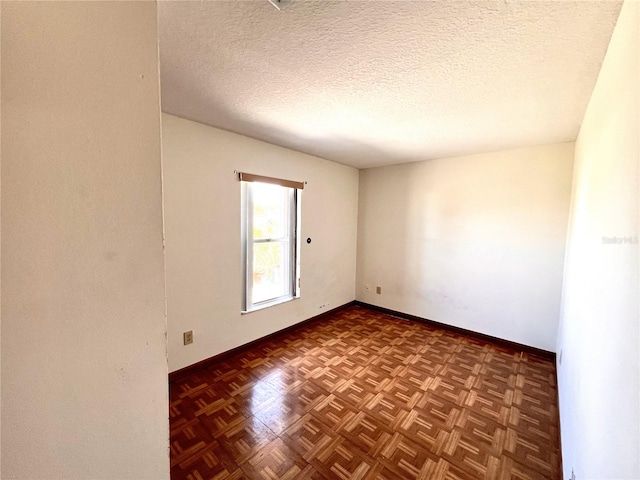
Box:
left=162, top=114, right=358, bottom=371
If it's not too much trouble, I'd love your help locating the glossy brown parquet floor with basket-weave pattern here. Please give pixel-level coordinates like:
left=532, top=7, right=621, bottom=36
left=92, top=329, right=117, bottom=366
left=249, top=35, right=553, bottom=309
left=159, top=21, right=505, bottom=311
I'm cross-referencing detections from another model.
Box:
left=170, top=306, right=560, bottom=480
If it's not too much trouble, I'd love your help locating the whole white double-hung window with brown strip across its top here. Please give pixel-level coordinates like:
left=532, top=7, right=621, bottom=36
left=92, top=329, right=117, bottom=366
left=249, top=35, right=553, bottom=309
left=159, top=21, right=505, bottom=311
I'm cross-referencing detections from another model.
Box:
left=240, top=173, right=303, bottom=312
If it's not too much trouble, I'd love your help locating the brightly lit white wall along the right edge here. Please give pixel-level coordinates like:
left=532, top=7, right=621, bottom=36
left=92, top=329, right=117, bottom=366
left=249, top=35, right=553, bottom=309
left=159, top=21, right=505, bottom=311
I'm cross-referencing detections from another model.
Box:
left=557, top=0, right=640, bottom=480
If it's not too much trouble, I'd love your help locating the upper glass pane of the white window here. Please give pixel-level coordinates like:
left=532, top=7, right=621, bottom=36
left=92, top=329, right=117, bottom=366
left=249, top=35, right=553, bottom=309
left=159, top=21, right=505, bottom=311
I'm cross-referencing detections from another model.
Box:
left=251, top=183, right=290, bottom=241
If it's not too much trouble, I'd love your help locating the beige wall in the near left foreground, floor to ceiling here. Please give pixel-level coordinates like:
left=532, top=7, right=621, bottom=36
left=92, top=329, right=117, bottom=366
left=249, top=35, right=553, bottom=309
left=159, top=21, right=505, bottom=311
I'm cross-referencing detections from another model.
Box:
left=1, top=2, right=169, bottom=480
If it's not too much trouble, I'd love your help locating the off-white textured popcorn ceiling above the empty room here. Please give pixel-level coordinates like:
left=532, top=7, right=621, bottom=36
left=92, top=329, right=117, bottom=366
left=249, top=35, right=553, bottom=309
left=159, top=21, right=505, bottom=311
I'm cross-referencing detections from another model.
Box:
left=158, top=0, right=621, bottom=168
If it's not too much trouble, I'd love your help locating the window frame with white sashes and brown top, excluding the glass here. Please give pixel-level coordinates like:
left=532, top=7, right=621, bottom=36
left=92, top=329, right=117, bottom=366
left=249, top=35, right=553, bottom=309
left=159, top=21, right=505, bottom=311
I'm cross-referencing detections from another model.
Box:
left=240, top=178, right=302, bottom=314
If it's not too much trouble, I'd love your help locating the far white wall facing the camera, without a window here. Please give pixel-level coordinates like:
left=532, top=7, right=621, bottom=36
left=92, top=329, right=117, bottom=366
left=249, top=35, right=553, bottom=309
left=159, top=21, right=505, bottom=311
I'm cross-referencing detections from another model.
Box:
left=356, top=143, right=573, bottom=351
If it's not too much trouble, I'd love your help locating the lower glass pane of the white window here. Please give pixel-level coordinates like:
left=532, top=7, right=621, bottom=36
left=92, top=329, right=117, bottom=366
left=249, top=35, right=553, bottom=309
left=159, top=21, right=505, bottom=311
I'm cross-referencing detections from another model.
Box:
left=253, top=241, right=291, bottom=304
